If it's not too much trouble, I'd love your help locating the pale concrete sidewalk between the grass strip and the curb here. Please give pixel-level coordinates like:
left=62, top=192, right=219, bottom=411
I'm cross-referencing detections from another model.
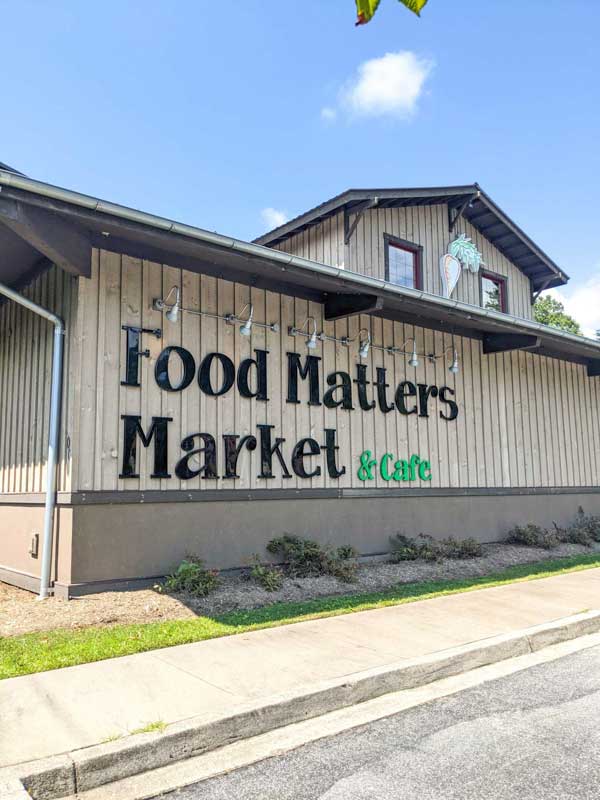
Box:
left=0, top=569, right=600, bottom=767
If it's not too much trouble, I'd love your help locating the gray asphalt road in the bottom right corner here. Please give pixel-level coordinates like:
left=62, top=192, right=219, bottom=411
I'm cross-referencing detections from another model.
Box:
left=161, top=647, right=600, bottom=800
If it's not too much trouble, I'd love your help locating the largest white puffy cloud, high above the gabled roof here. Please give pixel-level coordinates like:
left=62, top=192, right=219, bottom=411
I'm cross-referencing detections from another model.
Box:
left=338, top=50, right=434, bottom=119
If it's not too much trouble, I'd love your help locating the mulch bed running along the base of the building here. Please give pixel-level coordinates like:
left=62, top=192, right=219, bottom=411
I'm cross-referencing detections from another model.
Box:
left=0, top=543, right=600, bottom=637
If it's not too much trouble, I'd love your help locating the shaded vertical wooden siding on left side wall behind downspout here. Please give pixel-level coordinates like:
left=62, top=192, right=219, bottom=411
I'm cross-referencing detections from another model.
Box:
left=0, top=267, right=76, bottom=494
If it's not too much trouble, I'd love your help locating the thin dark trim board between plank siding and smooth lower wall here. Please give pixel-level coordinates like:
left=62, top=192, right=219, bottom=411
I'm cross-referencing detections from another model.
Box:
left=0, top=486, right=600, bottom=508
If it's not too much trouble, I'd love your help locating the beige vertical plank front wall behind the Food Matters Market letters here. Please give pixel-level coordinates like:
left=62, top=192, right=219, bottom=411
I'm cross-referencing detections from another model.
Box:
left=71, top=252, right=600, bottom=491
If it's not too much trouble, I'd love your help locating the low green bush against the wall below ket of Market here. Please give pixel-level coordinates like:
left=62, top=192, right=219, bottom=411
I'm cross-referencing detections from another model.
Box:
left=267, top=533, right=358, bottom=583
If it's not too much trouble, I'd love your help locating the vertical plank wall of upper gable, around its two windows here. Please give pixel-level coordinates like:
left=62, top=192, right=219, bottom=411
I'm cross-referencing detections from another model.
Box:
left=276, top=204, right=532, bottom=319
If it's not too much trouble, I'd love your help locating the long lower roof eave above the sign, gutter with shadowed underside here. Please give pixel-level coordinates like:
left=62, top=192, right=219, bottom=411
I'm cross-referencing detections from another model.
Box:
left=0, top=170, right=600, bottom=372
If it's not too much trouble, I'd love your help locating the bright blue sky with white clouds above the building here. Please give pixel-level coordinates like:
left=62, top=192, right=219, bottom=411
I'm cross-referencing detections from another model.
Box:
left=0, top=0, right=600, bottom=329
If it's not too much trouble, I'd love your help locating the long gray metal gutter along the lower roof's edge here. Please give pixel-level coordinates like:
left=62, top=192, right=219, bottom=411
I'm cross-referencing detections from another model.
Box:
left=0, top=170, right=600, bottom=358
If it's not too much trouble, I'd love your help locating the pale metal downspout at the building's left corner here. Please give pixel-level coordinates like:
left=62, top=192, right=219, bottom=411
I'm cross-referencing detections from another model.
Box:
left=0, top=283, right=65, bottom=600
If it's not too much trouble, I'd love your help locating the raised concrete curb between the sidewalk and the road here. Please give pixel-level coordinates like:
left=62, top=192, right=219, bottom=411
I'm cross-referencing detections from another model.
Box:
left=0, top=611, right=600, bottom=800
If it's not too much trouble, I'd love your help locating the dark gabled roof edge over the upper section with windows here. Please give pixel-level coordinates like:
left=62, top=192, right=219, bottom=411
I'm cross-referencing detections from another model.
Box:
left=254, top=183, right=569, bottom=291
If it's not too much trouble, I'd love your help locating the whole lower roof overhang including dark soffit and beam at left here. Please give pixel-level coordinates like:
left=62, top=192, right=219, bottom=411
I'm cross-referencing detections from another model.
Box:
left=0, top=170, right=600, bottom=376
